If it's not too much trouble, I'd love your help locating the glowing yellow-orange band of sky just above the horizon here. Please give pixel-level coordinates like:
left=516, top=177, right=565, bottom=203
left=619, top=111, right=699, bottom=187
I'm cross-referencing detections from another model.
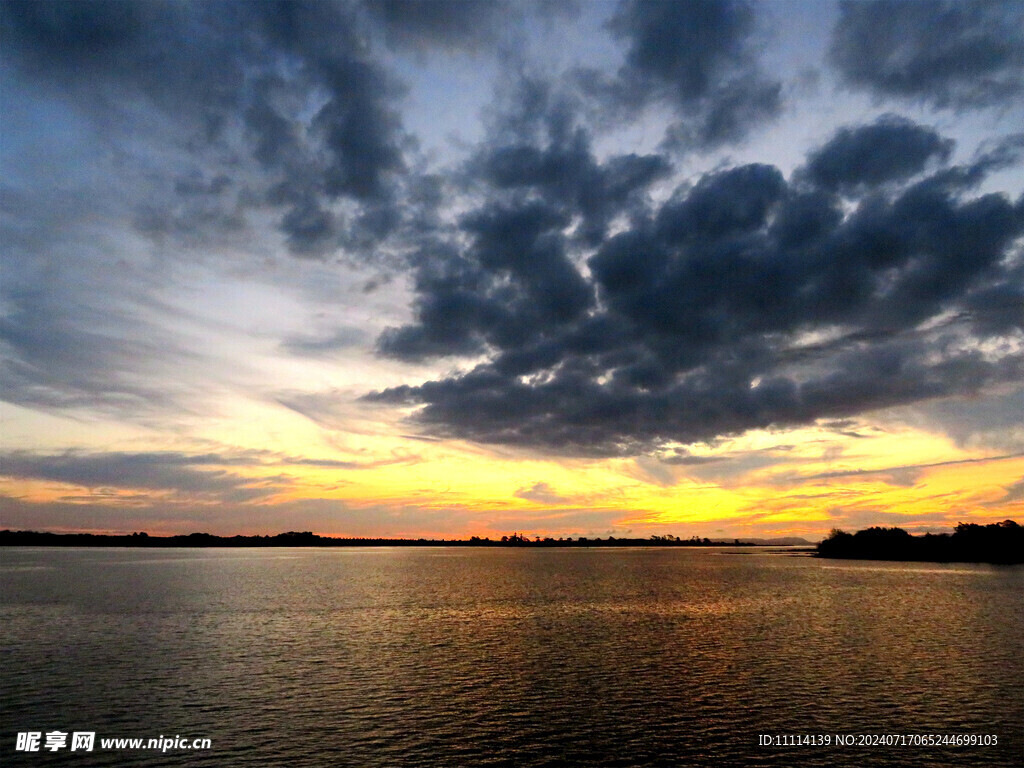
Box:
left=0, top=397, right=1024, bottom=539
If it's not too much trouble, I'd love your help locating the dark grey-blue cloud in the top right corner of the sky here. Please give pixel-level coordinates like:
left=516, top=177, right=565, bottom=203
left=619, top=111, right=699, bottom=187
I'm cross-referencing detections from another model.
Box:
left=829, top=0, right=1024, bottom=109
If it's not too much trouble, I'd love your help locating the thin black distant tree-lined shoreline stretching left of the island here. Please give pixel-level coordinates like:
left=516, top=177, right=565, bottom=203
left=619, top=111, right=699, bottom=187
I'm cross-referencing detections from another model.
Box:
left=0, top=530, right=811, bottom=548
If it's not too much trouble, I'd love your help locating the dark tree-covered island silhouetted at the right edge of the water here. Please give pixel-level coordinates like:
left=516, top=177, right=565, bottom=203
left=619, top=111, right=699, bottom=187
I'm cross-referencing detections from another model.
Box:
left=817, top=520, right=1024, bottom=564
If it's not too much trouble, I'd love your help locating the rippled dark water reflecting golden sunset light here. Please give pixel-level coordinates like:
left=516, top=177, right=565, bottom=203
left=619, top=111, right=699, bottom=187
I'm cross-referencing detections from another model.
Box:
left=0, top=548, right=1024, bottom=768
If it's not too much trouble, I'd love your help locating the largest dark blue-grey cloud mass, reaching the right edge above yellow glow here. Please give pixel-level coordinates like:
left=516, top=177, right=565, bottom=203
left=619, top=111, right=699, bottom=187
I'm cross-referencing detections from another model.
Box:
left=368, top=118, right=1024, bottom=455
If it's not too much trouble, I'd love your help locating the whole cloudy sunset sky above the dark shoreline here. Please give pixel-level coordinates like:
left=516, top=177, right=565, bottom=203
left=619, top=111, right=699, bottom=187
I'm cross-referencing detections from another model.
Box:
left=0, top=0, right=1024, bottom=540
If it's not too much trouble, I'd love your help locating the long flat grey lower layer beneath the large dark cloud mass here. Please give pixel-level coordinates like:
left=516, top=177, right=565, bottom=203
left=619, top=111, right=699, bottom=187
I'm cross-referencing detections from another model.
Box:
left=371, top=335, right=1024, bottom=456
